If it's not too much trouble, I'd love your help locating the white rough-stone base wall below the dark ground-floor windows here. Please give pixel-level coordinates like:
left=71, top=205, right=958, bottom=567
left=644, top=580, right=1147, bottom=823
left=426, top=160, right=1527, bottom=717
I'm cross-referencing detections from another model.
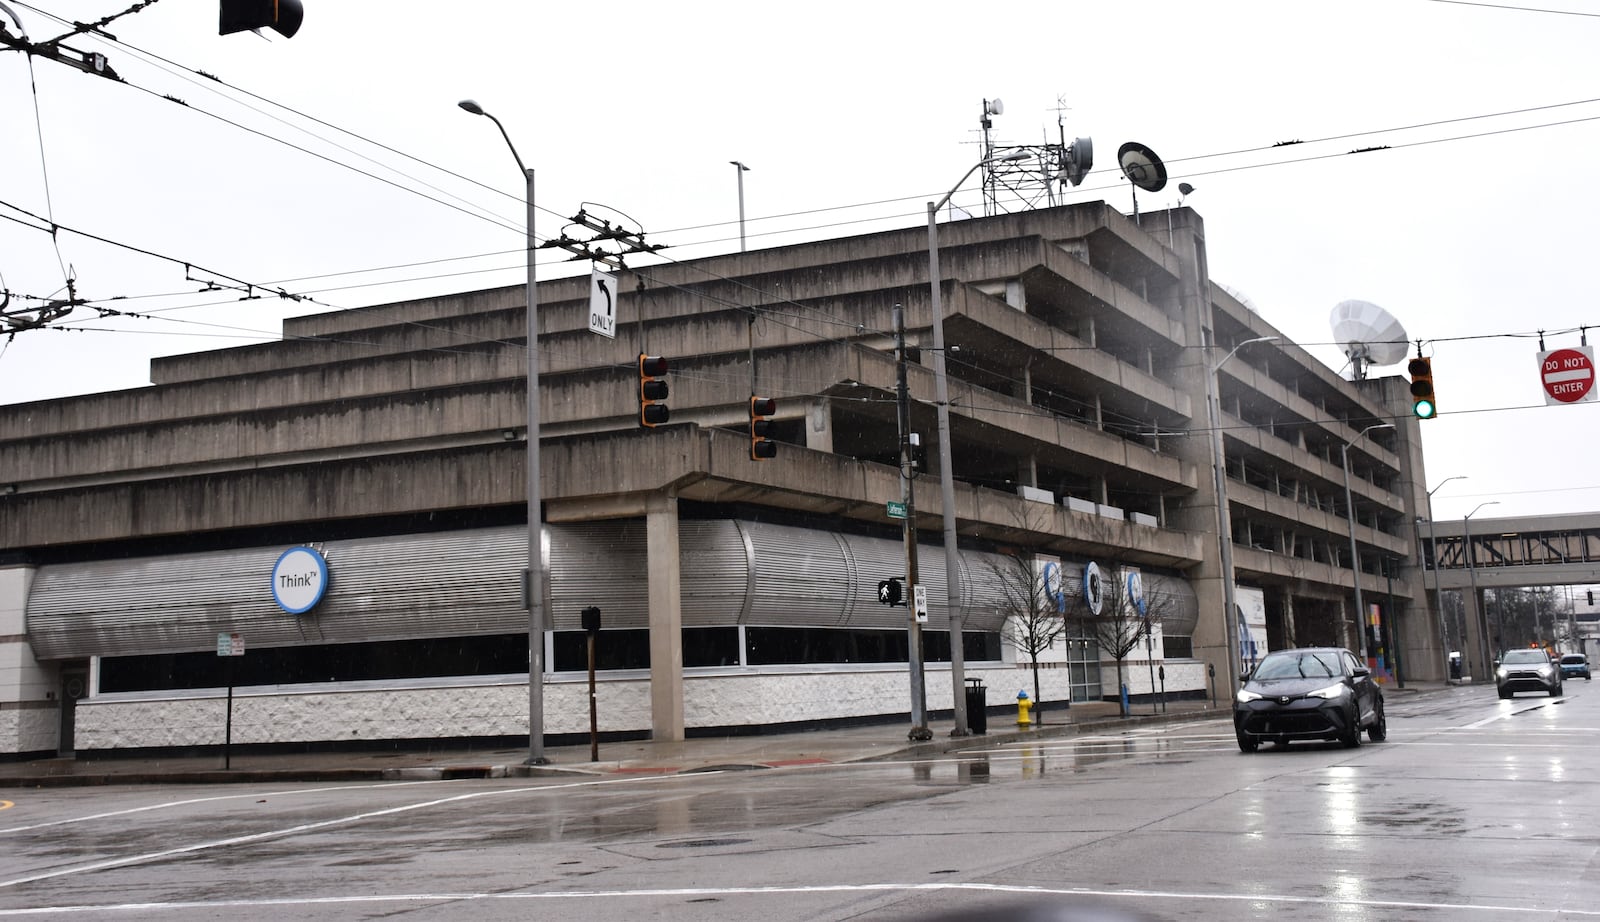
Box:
left=65, top=663, right=1205, bottom=752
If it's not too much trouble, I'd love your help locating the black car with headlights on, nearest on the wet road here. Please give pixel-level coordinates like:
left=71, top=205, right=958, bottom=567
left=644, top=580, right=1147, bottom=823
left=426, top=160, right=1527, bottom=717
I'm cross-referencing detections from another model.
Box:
left=1234, top=647, right=1389, bottom=752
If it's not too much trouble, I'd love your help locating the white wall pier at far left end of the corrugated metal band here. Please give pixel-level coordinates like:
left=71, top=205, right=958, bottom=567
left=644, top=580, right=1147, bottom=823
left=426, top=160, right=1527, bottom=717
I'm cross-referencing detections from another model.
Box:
left=0, top=567, right=55, bottom=756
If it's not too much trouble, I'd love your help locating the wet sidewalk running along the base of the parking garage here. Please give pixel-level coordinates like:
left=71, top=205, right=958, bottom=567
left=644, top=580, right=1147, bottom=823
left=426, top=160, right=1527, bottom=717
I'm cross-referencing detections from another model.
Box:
left=0, top=682, right=1446, bottom=789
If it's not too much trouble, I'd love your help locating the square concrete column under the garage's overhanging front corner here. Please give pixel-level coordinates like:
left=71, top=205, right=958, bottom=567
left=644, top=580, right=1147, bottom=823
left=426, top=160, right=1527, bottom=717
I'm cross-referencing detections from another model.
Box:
left=645, top=493, right=683, bottom=741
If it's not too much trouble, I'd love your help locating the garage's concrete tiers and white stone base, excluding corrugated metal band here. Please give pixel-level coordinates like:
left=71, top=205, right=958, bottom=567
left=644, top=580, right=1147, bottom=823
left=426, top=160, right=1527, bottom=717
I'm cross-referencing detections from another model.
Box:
left=0, top=203, right=1443, bottom=752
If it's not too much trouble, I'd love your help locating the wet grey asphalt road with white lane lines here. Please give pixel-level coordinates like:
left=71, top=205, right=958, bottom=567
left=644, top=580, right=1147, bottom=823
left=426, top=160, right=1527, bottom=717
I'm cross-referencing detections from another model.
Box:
left=0, top=682, right=1600, bottom=922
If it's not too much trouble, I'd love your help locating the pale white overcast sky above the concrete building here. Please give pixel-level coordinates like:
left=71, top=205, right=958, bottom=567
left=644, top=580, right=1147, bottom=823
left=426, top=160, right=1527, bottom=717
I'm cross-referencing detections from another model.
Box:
left=0, top=0, right=1600, bottom=520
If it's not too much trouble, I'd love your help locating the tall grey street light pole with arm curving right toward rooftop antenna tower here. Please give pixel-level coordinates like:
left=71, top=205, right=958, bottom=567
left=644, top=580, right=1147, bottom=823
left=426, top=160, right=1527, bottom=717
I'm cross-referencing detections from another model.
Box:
left=928, top=150, right=1024, bottom=736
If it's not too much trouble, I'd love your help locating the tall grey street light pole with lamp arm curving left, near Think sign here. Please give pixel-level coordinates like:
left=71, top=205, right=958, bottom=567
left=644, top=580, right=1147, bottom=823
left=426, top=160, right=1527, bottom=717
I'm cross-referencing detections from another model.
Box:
left=458, top=99, right=550, bottom=765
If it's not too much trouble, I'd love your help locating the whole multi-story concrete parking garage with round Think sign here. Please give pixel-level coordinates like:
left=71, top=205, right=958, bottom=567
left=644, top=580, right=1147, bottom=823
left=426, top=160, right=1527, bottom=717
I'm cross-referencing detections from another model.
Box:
left=0, top=203, right=1443, bottom=754
